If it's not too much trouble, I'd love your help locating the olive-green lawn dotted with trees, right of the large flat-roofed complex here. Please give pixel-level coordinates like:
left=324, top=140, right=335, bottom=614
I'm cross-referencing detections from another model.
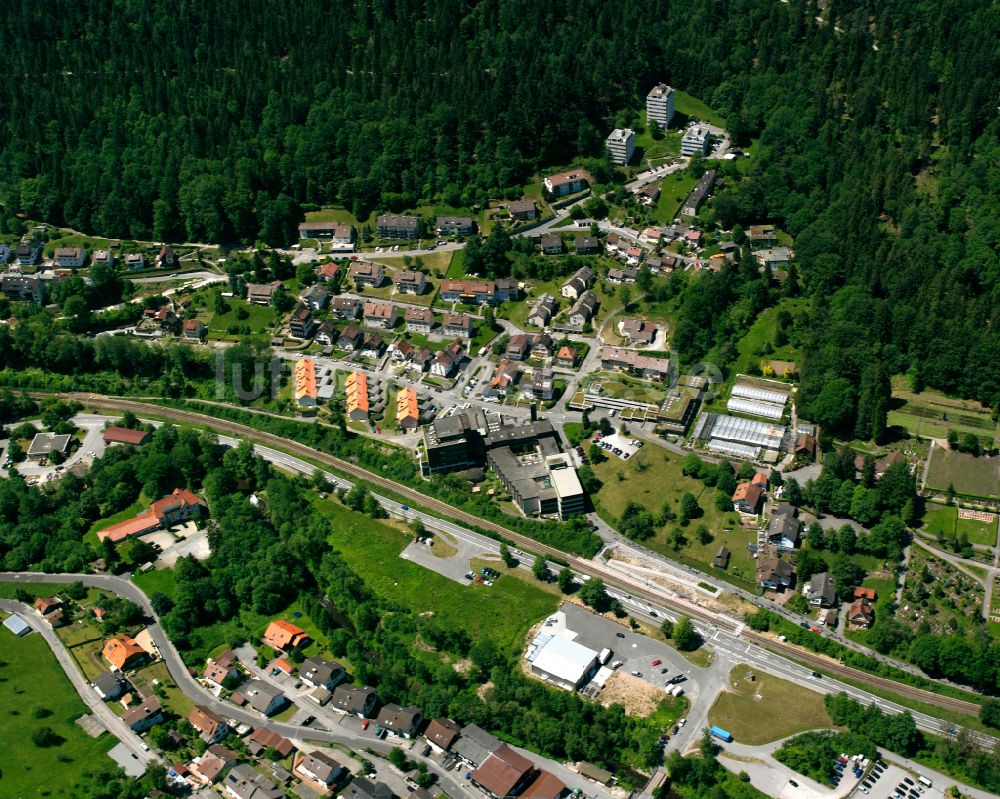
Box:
left=593, top=444, right=756, bottom=590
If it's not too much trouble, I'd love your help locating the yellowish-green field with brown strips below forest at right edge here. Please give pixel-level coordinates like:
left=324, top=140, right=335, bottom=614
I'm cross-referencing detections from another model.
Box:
left=889, top=375, right=998, bottom=446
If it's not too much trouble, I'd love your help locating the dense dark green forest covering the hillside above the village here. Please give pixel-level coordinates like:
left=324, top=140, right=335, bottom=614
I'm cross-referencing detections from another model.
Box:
left=0, top=0, right=1000, bottom=415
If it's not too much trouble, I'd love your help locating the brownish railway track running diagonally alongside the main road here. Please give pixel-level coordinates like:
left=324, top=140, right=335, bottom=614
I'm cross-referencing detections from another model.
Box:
left=64, top=393, right=979, bottom=716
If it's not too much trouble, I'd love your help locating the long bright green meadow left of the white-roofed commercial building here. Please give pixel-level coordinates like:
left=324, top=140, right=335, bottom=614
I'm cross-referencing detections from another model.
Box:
left=315, top=499, right=558, bottom=649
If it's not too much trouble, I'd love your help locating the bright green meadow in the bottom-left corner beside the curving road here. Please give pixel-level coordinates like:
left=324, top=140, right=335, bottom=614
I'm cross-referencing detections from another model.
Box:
left=0, top=629, right=116, bottom=797
